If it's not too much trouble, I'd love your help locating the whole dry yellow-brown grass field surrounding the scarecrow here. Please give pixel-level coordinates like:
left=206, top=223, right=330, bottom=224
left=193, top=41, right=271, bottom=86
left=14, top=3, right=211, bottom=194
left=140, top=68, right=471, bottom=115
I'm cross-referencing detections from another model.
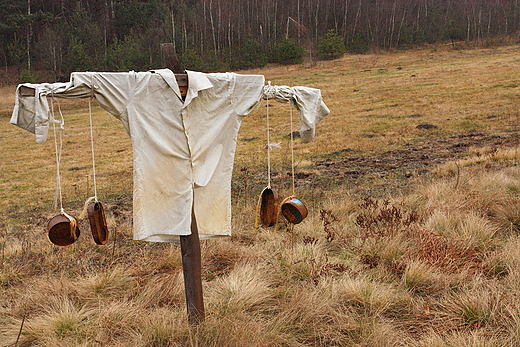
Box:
left=0, top=45, right=520, bottom=347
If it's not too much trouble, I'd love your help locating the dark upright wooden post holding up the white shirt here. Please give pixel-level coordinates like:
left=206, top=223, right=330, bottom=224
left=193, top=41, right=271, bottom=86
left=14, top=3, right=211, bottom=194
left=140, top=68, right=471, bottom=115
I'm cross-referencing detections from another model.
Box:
left=161, top=43, right=205, bottom=324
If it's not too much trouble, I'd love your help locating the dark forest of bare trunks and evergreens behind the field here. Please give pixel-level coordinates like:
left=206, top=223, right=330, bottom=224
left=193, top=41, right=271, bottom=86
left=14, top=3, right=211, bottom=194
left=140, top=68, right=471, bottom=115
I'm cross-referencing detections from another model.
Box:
left=0, top=0, right=520, bottom=80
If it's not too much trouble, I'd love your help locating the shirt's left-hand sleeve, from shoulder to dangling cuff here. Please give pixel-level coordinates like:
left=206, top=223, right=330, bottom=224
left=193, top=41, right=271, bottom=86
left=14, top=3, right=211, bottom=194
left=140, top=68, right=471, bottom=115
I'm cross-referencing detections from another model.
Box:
left=11, top=72, right=135, bottom=143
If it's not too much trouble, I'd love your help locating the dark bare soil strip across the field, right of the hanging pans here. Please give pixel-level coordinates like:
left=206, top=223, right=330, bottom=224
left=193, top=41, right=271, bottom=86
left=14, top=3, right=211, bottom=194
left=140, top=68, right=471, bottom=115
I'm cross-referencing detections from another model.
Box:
left=308, top=131, right=519, bottom=196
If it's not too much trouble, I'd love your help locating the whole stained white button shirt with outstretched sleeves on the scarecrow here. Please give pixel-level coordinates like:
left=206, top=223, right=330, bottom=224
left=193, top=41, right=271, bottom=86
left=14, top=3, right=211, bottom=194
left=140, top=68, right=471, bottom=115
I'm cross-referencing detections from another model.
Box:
left=11, top=69, right=329, bottom=242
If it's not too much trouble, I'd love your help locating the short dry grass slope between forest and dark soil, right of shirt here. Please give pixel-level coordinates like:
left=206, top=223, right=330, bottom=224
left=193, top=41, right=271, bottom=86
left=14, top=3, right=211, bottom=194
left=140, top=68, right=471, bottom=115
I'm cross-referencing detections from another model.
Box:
left=244, top=46, right=520, bottom=160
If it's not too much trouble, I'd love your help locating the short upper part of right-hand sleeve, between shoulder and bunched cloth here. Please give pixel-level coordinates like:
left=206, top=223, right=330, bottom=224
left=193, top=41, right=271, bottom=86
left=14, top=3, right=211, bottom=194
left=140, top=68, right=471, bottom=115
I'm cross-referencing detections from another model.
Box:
left=232, top=74, right=265, bottom=116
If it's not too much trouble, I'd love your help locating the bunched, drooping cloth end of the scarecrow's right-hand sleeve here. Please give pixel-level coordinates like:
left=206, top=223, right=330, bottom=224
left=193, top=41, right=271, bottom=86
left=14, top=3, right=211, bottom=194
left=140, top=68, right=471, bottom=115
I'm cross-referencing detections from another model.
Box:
left=262, top=84, right=330, bottom=142
